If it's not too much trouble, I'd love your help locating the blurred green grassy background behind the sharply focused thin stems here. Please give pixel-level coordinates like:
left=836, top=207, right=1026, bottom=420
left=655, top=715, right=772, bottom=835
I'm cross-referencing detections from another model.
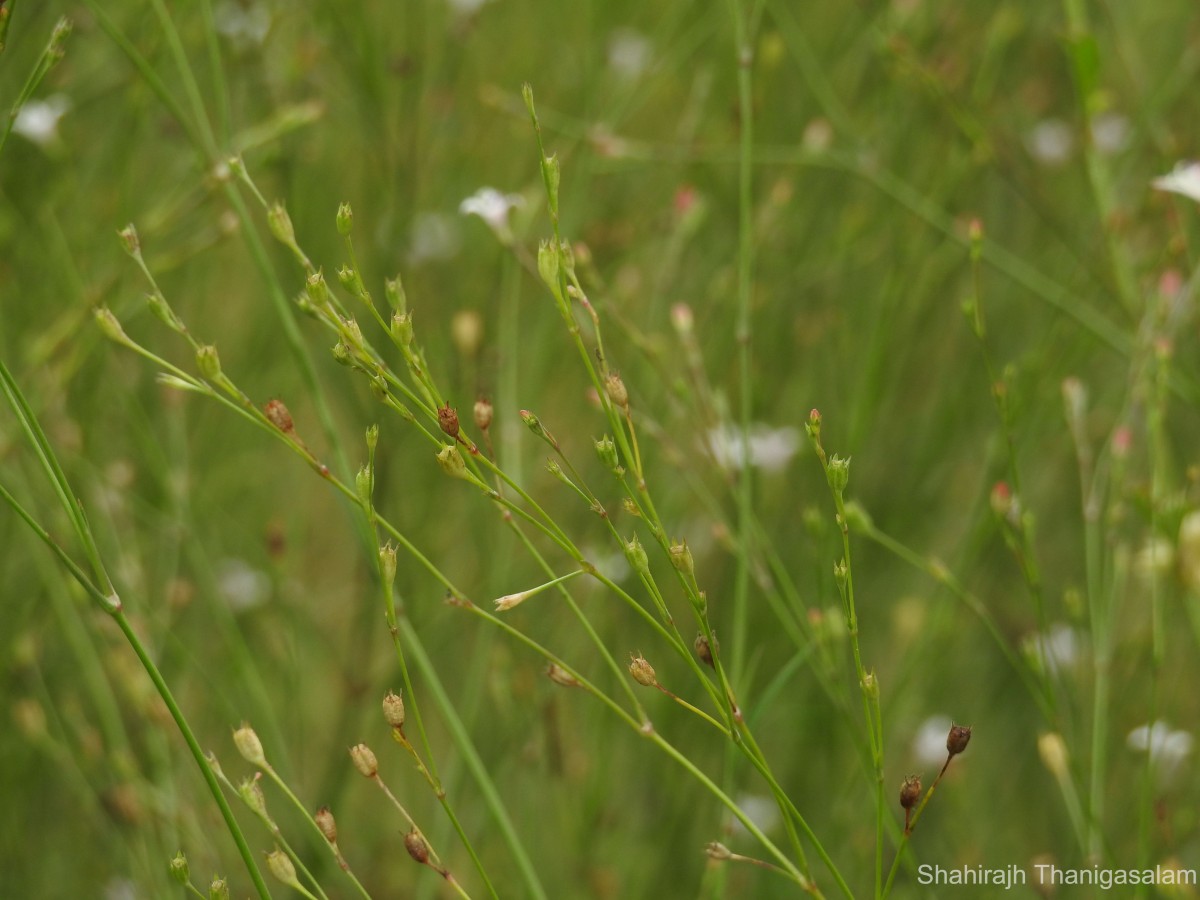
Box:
left=0, top=0, right=1200, bottom=898
